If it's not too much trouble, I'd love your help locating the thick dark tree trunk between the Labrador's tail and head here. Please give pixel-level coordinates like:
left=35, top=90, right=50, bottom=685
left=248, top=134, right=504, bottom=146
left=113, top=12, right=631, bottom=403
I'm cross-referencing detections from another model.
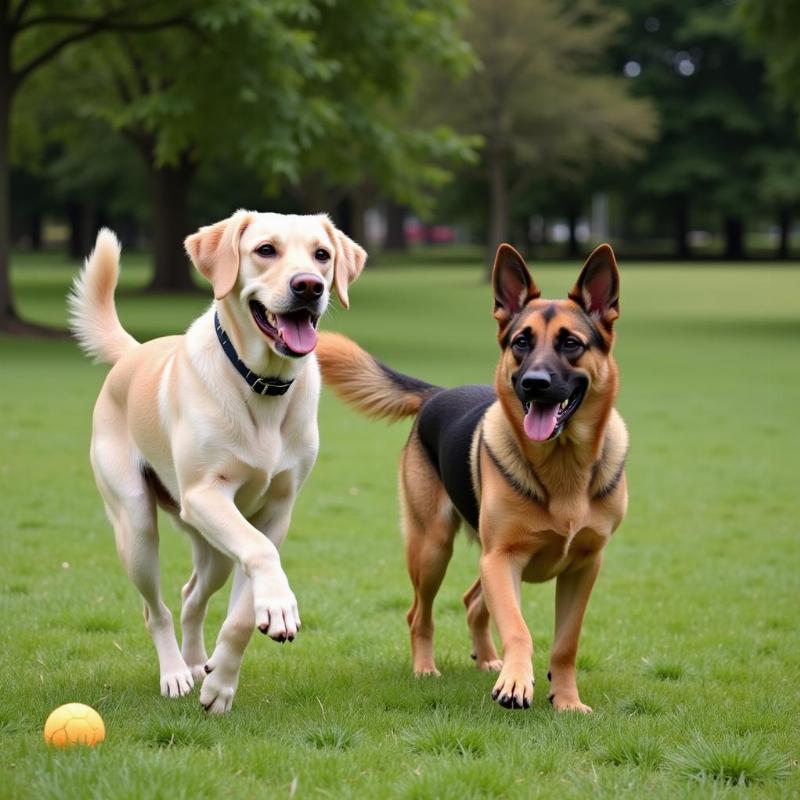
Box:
left=147, top=159, right=194, bottom=292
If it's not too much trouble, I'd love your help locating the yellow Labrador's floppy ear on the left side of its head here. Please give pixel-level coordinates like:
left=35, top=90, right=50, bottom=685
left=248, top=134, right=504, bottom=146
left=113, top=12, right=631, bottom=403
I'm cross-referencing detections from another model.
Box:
left=183, top=209, right=253, bottom=300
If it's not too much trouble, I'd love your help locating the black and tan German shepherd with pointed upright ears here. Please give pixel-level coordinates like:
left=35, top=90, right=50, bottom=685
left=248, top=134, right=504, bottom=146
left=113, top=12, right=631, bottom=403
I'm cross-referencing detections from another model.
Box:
left=317, top=244, right=628, bottom=712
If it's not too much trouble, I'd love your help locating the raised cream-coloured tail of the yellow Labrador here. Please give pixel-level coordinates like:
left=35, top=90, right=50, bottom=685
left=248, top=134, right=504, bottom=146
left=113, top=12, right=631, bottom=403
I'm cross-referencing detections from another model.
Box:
left=67, top=228, right=139, bottom=364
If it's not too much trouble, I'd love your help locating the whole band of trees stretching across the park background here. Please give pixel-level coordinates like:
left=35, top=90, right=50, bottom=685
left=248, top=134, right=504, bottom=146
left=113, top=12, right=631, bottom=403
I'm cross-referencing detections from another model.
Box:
left=0, top=0, right=800, bottom=330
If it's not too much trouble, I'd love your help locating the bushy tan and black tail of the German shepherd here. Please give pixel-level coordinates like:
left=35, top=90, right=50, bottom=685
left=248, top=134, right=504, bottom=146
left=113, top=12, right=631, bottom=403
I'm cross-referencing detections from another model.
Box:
left=316, top=332, right=442, bottom=420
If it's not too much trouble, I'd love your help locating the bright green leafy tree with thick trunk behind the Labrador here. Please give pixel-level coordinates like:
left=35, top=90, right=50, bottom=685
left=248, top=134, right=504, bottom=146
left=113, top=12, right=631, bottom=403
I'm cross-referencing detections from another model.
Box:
left=50, top=0, right=478, bottom=290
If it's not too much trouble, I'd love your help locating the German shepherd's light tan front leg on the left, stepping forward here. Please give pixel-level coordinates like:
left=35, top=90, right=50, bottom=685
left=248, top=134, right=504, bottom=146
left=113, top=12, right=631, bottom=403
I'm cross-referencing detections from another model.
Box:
left=481, top=549, right=534, bottom=708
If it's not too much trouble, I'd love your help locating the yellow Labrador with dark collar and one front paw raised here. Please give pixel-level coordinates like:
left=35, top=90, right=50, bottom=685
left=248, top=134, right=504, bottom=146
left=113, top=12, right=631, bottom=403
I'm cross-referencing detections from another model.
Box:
left=69, top=211, right=366, bottom=713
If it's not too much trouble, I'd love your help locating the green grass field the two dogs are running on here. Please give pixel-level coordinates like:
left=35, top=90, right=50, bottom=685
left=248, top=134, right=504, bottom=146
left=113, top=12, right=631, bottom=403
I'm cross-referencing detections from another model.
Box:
left=0, top=259, right=800, bottom=800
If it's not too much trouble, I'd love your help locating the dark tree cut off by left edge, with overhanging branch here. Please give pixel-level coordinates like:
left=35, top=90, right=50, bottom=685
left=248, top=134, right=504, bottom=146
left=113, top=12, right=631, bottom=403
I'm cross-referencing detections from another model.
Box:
left=0, top=0, right=194, bottom=332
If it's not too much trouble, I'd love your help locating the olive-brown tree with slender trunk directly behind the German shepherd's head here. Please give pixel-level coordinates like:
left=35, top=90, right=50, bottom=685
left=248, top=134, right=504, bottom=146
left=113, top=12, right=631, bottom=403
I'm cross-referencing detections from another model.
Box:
left=418, top=0, right=656, bottom=268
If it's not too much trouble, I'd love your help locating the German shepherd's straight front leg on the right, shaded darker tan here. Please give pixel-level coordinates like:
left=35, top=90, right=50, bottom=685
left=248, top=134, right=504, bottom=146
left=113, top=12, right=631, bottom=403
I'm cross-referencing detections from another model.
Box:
left=548, top=550, right=603, bottom=714
